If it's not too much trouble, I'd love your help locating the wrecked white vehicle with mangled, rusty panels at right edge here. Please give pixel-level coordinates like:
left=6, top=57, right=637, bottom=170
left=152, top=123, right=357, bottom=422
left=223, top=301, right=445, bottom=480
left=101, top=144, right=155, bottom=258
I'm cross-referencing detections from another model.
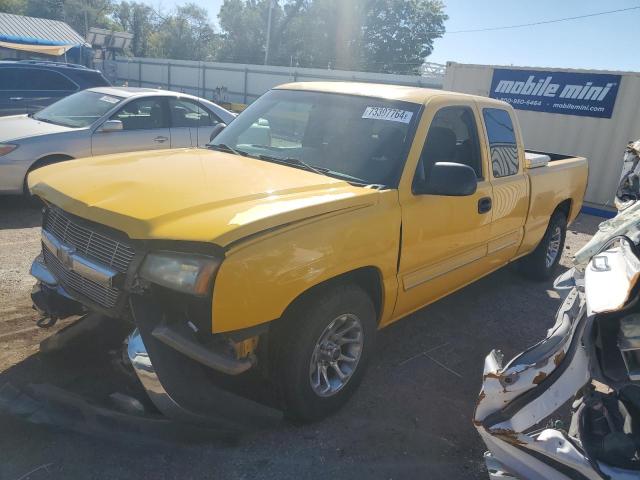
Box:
left=474, top=140, right=640, bottom=480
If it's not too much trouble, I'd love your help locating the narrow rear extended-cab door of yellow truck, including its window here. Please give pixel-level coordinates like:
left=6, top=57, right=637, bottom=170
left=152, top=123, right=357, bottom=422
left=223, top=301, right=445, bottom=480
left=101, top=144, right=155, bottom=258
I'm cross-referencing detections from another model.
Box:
left=480, top=105, right=529, bottom=268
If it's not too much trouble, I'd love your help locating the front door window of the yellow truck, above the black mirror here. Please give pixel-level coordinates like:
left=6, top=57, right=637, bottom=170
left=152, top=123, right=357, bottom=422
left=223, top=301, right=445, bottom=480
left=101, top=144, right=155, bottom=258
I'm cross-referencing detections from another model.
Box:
left=415, top=106, right=483, bottom=187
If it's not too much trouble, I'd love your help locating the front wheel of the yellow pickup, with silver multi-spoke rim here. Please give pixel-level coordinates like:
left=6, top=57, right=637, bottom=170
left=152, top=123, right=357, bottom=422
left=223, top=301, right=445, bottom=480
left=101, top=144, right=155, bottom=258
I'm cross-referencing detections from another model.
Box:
left=272, top=284, right=377, bottom=422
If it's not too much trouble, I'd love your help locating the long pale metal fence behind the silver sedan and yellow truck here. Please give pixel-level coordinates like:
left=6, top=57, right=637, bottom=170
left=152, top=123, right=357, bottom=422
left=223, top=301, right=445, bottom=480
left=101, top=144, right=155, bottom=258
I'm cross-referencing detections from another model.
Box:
left=101, top=57, right=444, bottom=104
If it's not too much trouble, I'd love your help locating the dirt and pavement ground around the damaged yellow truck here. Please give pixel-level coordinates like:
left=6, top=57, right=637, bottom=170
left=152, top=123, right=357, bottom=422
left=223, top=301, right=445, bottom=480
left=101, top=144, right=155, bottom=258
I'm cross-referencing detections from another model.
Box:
left=0, top=197, right=601, bottom=480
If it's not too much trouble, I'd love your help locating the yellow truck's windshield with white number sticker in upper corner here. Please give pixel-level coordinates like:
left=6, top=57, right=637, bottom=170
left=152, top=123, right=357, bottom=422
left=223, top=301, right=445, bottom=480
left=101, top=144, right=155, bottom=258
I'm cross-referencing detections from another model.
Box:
left=210, top=89, right=420, bottom=187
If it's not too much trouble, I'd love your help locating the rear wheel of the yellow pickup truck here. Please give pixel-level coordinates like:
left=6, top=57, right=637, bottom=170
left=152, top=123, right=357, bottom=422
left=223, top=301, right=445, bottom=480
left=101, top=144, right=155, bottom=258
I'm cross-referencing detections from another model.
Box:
left=520, top=211, right=567, bottom=281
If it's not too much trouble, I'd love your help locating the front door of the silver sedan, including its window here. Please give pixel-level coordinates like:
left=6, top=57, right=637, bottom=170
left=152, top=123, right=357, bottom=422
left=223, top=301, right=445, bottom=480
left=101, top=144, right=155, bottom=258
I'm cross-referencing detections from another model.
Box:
left=91, top=97, right=171, bottom=155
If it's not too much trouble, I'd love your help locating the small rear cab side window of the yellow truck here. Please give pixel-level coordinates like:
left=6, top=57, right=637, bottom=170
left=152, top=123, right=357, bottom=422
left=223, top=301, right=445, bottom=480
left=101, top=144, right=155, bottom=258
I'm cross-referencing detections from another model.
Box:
left=482, top=108, right=520, bottom=178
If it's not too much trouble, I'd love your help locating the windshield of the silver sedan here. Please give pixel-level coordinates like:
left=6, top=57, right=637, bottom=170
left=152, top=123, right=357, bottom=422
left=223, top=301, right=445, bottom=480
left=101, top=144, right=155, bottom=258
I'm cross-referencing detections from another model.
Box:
left=33, top=90, right=123, bottom=128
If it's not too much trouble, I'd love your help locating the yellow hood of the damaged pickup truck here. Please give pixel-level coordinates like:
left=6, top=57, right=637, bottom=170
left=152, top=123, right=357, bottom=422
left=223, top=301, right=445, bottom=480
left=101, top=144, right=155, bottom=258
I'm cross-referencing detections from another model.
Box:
left=29, top=149, right=378, bottom=246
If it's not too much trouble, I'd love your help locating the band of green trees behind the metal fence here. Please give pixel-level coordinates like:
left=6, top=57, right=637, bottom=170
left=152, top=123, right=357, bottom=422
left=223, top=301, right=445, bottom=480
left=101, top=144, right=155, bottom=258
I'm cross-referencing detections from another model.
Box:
left=0, top=0, right=448, bottom=73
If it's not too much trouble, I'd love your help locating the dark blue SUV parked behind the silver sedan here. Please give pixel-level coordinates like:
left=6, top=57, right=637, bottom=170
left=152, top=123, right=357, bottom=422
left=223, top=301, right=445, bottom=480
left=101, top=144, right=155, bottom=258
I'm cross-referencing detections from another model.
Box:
left=0, top=60, right=110, bottom=116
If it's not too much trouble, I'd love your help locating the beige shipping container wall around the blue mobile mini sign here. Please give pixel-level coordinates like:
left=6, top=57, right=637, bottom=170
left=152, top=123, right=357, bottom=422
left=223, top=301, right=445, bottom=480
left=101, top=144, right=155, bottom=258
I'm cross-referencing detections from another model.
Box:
left=444, top=62, right=640, bottom=212
